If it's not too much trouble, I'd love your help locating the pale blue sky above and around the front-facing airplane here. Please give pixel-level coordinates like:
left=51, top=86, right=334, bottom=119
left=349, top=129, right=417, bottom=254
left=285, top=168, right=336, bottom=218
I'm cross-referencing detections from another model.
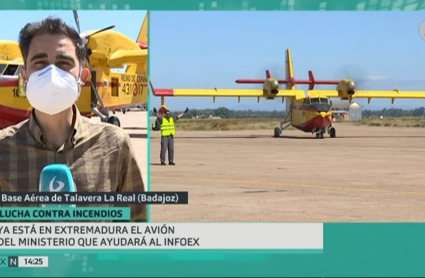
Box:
left=149, top=11, right=425, bottom=110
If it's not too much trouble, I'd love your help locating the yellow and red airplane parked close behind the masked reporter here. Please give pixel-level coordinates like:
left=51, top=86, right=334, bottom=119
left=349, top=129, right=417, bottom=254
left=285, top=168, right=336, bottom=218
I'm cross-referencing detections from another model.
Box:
left=0, top=11, right=148, bottom=129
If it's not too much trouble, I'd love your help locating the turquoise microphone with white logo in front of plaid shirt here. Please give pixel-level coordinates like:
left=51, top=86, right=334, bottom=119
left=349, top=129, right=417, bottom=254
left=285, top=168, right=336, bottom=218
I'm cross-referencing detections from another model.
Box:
left=39, top=164, right=77, bottom=207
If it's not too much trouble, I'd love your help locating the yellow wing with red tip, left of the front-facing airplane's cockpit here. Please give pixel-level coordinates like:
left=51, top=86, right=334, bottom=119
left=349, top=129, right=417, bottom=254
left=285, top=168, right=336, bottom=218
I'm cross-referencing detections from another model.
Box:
left=153, top=88, right=305, bottom=99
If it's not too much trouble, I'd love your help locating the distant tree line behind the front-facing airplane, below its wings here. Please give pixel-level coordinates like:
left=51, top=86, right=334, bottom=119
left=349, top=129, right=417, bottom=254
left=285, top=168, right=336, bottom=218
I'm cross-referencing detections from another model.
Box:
left=165, top=107, right=425, bottom=119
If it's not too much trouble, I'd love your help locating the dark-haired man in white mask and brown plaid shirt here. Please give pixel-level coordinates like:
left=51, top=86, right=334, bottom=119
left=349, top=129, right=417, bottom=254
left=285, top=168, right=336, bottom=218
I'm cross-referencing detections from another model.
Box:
left=0, top=17, right=147, bottom=222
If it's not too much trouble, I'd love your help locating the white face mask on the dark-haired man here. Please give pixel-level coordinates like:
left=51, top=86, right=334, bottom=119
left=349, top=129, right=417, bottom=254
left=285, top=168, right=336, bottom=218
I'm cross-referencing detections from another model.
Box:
left=26, top=65, right=82, bottom=115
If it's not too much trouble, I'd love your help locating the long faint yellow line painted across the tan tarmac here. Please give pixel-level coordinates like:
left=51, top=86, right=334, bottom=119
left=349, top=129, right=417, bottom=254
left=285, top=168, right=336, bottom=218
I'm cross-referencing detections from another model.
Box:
left=150, top=176, right=425, bottom=195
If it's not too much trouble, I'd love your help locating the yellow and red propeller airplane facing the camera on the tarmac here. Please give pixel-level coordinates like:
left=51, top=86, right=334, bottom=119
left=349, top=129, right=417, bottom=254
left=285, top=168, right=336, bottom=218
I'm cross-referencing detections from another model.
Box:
left=151, top=48, right=425, bottom=138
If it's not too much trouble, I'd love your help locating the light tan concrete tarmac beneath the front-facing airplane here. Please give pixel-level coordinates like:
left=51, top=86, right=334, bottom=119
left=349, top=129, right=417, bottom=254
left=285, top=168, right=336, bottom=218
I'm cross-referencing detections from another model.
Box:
left=150, top=123, right=425, bottom=222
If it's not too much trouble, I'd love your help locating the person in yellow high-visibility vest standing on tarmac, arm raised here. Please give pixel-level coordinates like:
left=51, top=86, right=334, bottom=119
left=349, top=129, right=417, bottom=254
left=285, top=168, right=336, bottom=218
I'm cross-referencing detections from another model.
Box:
left=155, top=108, right=189, bottom=165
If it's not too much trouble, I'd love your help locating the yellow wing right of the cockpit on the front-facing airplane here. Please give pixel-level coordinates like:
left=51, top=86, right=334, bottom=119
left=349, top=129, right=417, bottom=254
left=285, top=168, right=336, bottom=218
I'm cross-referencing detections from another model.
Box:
left=308, top=90, right=425, bottom=102
